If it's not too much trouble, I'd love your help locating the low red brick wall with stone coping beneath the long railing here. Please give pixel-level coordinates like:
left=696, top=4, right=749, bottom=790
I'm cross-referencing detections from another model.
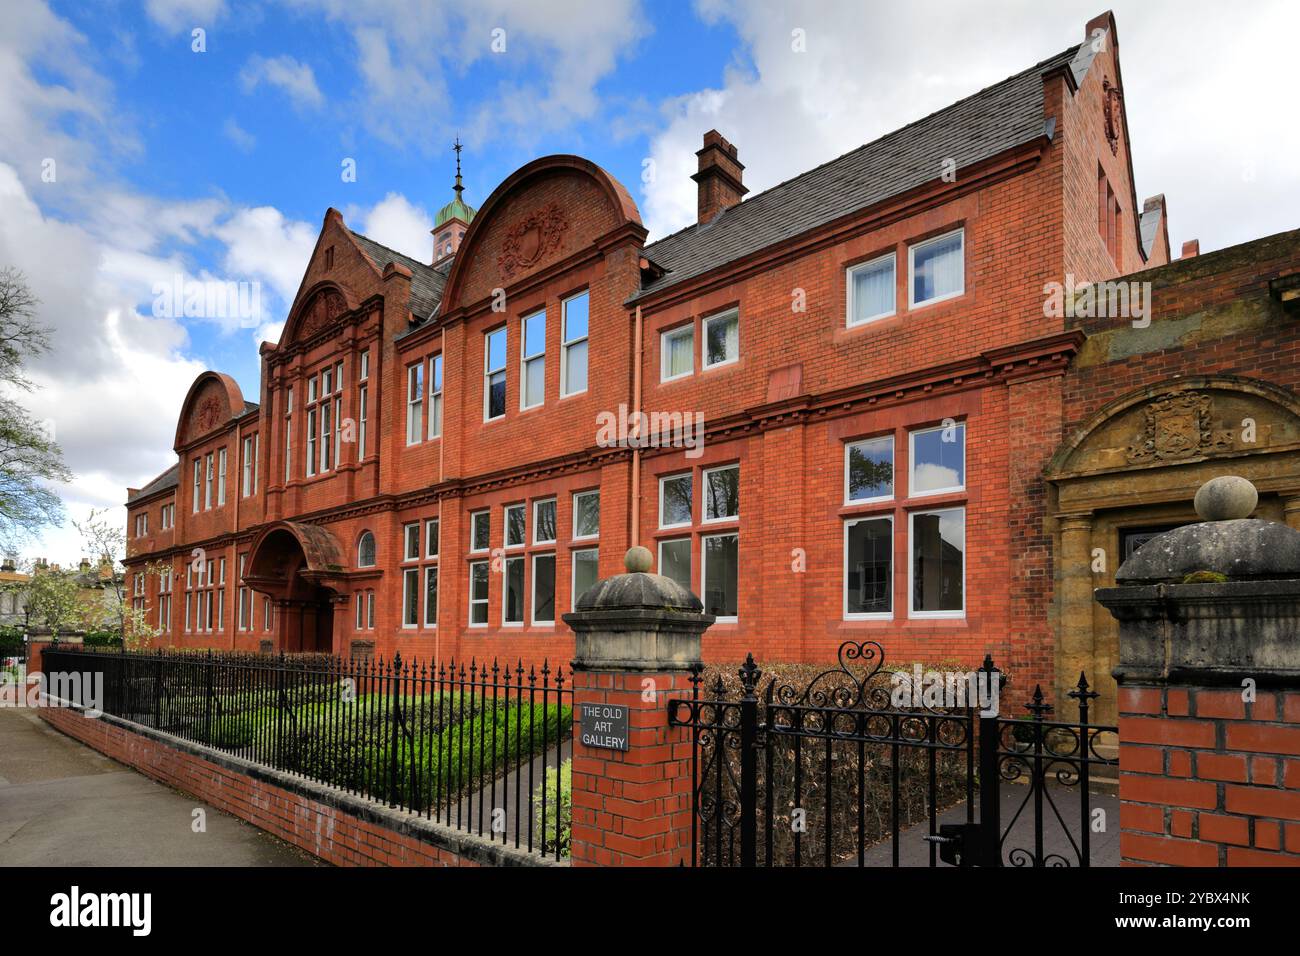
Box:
left=40, top=708, right=556, bottom=866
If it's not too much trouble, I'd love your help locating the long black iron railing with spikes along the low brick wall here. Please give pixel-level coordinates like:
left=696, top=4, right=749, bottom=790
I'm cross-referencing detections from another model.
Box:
left=42, top=648, right=573, bottom=858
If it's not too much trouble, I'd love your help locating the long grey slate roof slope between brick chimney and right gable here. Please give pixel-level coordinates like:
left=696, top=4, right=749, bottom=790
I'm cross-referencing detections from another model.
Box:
left=632, top=43, right=1091, bottom=300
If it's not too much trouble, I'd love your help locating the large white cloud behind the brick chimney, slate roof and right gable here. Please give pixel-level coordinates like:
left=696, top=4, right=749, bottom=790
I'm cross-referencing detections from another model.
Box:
left=642, top=0, right=1300, bottom=250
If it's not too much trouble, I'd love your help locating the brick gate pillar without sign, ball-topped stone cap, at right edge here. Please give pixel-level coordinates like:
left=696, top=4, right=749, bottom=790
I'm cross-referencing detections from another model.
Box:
left=1097, top=477, right=1300, bottom=866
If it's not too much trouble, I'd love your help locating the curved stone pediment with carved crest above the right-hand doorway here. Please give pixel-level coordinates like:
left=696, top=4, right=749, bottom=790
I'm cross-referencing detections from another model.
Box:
left=1047, top=376, right=1300, bottom=480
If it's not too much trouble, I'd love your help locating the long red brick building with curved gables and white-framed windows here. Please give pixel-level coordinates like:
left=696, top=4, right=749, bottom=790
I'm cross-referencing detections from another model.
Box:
left=127, top=14, right=1170, bottom=697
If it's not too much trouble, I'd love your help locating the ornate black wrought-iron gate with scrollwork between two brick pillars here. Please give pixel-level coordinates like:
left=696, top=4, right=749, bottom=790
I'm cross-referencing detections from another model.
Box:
left=668, top=641, right=1118, bottom=866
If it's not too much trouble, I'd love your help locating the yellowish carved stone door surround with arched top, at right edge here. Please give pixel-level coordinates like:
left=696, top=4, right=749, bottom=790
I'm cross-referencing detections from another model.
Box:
left=1045, top=376, right=1300, bottom=723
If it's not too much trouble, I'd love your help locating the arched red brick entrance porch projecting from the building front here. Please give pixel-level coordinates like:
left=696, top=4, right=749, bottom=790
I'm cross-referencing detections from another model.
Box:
left=243, top=522, right=347, bottom=653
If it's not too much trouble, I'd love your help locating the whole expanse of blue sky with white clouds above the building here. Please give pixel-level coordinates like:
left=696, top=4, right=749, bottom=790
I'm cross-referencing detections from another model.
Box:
left=0, top=0, right=1300, bottom=561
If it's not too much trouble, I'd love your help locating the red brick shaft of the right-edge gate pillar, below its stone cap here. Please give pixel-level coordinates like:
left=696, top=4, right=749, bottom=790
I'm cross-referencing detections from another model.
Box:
left=1119, top=684, right=1300, bottom=866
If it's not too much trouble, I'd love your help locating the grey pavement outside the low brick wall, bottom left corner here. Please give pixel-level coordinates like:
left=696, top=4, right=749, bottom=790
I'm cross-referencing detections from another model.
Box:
left=0, top=706, right=324, bottom=866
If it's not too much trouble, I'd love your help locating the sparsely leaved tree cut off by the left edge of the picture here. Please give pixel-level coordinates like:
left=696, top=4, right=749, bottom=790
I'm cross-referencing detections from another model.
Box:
left=0, top=268, right=72, bottom=550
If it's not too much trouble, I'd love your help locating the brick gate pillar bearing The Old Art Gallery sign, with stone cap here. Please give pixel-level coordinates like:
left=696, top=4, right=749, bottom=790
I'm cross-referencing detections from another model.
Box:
left=564, top=548, right=714, bottom=866
